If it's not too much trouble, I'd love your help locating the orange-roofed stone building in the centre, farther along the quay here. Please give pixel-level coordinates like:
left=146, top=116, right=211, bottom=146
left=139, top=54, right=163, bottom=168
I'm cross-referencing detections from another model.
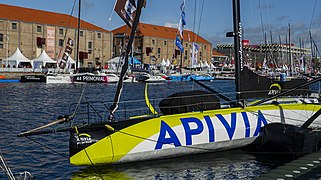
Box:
left=112, top=23, right=212, bottom=66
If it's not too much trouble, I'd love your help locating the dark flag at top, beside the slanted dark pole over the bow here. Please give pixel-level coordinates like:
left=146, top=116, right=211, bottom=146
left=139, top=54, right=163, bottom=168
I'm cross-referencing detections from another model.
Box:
left=114, top=0, right=136, bottom=28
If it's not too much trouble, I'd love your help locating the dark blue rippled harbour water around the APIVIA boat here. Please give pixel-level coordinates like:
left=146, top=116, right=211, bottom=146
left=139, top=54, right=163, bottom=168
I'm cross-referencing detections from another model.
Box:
left=0, top=81, right=288, bottom=179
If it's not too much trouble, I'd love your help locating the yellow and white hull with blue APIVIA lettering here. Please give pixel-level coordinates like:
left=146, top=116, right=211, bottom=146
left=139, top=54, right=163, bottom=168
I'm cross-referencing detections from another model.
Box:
left=70, top=100, right=321, bottom=165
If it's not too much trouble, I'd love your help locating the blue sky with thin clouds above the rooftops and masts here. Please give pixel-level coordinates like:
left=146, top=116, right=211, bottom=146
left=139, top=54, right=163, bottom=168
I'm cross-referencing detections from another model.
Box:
left=0, top=0, right=321, bottom=49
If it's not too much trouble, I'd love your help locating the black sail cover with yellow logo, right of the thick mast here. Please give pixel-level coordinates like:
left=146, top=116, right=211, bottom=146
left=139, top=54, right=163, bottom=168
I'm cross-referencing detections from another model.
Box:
left=241, top=66, right=309, bottom=99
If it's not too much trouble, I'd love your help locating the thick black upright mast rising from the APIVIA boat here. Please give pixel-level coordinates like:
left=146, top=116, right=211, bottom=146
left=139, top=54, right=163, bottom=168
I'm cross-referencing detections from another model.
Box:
left=232, top=0, right=243, bottom=102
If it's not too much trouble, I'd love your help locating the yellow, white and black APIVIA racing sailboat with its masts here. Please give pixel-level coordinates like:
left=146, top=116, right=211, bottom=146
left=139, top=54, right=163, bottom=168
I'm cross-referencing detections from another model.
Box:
left=19, top=0, right=321, bottom=166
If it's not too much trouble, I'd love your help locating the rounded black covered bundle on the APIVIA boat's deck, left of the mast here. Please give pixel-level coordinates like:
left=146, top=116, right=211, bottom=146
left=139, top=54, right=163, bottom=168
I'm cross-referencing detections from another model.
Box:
left=159, top=90, right=220, bottom=115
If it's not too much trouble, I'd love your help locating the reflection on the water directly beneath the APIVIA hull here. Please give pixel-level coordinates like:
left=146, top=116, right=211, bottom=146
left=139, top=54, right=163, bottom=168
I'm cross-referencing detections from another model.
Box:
left=71, top=150, right=270, bottom=179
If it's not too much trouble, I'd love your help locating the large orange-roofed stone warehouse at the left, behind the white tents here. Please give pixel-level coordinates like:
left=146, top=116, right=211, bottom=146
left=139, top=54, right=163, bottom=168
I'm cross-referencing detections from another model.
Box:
left=0, top=4, right=113, bottom=67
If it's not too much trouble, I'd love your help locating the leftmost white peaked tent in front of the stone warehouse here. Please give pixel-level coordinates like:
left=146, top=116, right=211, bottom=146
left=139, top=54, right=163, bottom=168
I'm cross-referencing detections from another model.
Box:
left=4, top=48, right=32, bottom=67
